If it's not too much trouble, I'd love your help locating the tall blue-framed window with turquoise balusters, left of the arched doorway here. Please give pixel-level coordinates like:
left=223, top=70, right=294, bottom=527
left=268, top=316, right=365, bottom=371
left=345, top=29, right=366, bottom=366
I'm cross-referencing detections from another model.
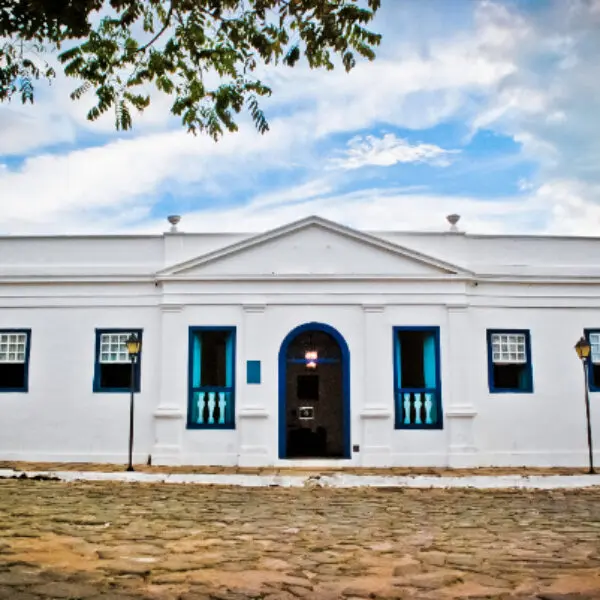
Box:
left=187, top=326, right=236, bottom=429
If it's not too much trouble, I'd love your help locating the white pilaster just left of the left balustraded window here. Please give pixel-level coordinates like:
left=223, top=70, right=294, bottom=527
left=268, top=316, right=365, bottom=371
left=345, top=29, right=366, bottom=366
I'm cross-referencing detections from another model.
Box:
left=152, top=304, right=188, bottom=465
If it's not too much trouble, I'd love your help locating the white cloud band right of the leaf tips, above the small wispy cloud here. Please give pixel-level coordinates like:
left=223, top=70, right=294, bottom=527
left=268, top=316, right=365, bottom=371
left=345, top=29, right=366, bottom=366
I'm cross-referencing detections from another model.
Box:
left=266, top=37, right=515, bottom=138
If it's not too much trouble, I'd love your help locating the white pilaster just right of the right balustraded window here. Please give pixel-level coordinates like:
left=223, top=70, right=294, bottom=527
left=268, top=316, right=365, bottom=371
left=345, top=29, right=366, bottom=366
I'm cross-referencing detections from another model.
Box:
left=442, top=305, right=477, bottom=468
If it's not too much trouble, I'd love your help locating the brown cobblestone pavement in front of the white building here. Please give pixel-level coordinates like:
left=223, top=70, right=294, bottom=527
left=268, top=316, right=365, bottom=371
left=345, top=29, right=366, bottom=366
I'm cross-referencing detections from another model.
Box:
left=0, top=479, right=600, bottom=600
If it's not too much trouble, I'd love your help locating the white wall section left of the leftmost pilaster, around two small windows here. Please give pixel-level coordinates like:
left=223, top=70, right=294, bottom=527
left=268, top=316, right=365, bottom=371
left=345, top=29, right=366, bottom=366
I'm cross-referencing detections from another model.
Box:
left=0, top=306, right=159, bottom=462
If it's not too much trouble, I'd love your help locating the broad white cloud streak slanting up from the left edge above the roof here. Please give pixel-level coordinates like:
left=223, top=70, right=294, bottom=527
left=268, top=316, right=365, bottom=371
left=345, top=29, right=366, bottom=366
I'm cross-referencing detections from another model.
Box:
left=0, top=108, right=325, bottom=233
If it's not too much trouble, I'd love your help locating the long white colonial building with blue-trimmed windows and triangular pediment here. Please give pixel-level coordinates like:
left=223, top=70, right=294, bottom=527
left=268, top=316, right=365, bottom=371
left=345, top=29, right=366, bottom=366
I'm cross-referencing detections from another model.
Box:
left=0, top=217, right=600, bottom=467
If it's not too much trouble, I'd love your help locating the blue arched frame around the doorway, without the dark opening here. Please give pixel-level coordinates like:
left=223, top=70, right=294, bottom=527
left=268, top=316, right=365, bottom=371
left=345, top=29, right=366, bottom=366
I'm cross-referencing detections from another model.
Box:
left=279, top=322, right=350, bottom=458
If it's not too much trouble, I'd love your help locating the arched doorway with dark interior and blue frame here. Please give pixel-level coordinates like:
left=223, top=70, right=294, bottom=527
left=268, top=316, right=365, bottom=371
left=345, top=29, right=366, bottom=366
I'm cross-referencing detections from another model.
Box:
left=279, top=323, right=350, bottom=458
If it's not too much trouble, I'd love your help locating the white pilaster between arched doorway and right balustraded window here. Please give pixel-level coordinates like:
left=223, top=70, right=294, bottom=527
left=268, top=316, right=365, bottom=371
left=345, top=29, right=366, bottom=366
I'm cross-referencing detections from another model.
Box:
left=354, top=304, right=394, bottom=467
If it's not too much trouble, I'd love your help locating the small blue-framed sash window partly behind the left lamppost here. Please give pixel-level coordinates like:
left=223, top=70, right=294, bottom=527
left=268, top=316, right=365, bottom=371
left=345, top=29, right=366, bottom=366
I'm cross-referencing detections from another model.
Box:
left=93, top=329, right=144, bottom=393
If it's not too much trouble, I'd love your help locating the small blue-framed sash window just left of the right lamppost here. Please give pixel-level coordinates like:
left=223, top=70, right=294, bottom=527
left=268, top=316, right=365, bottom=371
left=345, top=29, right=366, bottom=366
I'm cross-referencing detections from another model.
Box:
left=487, top=329, right=533, bottom=394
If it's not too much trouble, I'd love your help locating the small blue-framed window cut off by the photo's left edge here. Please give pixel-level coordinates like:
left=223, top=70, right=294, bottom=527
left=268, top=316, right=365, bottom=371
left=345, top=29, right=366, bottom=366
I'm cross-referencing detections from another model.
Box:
left=0, top=329, right=31, bottom=392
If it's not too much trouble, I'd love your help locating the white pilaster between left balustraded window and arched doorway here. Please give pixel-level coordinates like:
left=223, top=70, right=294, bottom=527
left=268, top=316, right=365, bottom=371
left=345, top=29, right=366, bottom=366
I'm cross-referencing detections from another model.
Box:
left=237, top=304, right=268, bottom=467
